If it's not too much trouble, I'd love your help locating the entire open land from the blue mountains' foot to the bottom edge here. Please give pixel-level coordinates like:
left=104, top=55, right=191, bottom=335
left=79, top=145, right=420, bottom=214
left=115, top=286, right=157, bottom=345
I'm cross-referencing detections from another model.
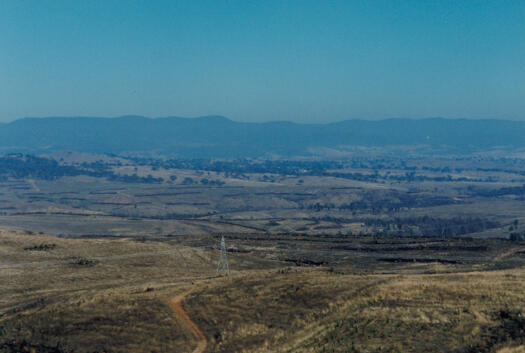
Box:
left=0, top=156, right=525, bottom=353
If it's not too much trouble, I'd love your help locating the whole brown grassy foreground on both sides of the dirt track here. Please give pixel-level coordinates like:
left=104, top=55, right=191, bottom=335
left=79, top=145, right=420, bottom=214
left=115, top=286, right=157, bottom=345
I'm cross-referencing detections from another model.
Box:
left=0, top=230, right=525, bottom=352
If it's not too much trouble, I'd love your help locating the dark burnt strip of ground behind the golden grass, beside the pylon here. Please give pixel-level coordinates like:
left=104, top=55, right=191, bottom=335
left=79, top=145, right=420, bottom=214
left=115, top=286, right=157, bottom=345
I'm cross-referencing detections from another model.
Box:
left=172, top=233, right=525, bottom=274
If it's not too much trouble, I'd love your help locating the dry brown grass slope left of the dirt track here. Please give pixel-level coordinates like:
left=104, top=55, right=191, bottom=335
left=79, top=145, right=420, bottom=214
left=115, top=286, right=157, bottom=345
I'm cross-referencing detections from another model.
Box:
left=0, top=231, right=222, bottom=352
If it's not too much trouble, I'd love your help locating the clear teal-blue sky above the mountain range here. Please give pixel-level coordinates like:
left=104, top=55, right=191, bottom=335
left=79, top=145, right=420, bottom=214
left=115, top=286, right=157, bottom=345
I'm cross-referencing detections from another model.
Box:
left=0, top=0, right=525, bottom=123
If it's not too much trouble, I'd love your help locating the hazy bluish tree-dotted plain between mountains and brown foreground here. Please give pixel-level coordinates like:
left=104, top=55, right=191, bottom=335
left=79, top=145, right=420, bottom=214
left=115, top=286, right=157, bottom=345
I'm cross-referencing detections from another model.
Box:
left=0, top=154, right=525, bottom=242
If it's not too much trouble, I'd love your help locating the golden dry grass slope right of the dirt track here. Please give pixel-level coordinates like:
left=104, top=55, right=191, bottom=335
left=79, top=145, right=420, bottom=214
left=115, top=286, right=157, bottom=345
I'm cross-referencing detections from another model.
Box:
left=185, top=269, right=525, bottom=352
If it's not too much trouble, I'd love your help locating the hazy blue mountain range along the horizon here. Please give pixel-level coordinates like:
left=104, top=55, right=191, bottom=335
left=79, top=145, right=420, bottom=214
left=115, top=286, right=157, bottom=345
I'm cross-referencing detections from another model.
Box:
left=0, top=116, right=525, bottom=158
